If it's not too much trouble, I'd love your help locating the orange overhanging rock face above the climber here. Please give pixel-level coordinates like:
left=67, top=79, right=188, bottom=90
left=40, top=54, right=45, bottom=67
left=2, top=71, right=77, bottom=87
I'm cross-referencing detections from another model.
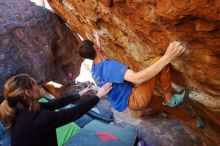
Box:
left=49, top=0, right=220, bottom=111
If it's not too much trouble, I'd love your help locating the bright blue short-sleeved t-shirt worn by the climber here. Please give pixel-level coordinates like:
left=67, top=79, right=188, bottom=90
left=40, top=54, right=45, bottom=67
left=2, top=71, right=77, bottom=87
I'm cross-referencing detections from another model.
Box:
left=92, top=59, right=133, bottom=112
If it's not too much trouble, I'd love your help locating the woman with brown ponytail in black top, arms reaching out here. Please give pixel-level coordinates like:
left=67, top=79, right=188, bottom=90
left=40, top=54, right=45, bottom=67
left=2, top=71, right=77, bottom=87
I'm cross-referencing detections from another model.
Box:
left=0, top=74, right=111, bottom=146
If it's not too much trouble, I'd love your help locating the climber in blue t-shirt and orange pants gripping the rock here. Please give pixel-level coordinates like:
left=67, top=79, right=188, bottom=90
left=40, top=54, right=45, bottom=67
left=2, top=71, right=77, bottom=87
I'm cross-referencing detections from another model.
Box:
left=78, top=32, right=205, bottom=127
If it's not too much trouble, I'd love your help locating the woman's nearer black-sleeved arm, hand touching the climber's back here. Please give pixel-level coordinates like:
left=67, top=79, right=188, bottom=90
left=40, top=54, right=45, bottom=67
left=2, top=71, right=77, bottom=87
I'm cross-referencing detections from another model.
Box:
left=33, top=83, right=112, bottom=132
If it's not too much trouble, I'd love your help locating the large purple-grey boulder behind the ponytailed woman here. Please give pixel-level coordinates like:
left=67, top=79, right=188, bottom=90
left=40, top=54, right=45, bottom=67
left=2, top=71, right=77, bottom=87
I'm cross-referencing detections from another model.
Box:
left=0, top=0, right=81, bottom=95
